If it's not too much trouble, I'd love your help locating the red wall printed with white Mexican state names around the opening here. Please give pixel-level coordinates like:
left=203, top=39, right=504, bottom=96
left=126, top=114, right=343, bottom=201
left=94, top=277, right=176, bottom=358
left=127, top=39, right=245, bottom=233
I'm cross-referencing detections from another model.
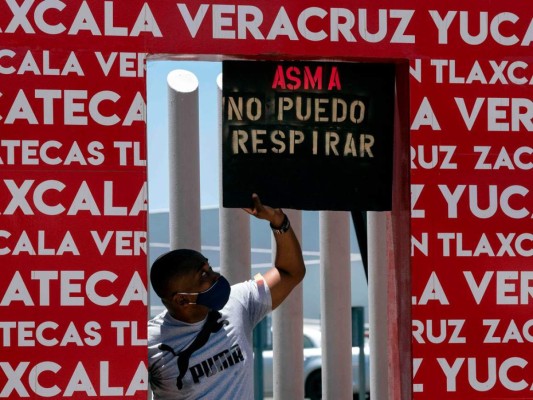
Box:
left=0, top=0, right=533, bottom=399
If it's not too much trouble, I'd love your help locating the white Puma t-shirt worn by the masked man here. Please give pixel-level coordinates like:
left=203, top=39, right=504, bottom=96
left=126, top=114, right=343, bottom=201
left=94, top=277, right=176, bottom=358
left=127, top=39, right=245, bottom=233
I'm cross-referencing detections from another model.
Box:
left=148, top=280, right=272, bottom=400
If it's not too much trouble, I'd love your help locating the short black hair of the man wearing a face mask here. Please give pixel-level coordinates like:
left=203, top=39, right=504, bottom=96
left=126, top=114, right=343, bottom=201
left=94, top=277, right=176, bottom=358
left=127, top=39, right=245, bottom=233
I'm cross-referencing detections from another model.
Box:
left=150, top=249, right=207, bottom=298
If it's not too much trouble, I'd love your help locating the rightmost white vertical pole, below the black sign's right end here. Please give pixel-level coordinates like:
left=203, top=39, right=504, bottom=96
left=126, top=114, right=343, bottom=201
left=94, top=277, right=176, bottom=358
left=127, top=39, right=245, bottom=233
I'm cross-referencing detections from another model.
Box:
left=367, top=212, right=389, bottom=400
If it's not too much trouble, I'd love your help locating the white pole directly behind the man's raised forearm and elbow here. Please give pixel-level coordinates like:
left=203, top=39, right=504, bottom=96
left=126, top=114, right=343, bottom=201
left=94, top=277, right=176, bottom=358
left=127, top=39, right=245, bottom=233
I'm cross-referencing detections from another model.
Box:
left=272, top=210, right=304, bottom=399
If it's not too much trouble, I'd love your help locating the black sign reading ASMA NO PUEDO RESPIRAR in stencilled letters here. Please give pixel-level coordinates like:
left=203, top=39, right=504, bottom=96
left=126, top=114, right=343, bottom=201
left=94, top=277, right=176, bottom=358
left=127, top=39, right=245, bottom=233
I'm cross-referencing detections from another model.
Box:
left=222, top=61, right=395, bottom=211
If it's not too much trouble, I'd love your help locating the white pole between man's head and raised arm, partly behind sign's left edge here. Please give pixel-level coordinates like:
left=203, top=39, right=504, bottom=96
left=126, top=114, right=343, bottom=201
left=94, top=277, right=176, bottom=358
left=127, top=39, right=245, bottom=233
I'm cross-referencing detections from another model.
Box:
left=217, top=74, right=252, bottom=284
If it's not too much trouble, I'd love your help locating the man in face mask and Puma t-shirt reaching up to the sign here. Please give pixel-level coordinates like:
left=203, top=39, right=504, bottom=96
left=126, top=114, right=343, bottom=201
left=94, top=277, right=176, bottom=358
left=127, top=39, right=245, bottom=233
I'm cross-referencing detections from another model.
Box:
left=148, top=194, right=305, bottom=400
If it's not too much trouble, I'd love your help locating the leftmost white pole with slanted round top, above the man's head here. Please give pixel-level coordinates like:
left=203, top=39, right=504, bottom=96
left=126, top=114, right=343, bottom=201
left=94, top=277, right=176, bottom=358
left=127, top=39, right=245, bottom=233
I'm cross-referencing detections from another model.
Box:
left=167, top=69, right=201, bottom=251
